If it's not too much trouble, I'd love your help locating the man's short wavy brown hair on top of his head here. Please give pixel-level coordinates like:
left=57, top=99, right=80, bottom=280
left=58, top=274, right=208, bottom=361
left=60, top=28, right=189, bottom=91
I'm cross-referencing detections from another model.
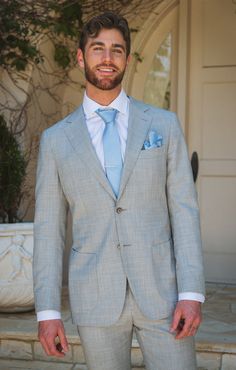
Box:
left=79, top=12, right=130, bottom=57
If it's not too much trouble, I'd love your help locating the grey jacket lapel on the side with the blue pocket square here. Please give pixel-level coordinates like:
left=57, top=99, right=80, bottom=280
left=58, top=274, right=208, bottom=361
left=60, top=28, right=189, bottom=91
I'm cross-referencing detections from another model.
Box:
left=118, top=98, right=152, bottom=199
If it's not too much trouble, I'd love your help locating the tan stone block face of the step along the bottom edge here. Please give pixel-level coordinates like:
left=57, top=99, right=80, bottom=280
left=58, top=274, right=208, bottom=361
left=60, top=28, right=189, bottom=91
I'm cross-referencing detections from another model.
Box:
left=0, top=327, right=236, bottom=370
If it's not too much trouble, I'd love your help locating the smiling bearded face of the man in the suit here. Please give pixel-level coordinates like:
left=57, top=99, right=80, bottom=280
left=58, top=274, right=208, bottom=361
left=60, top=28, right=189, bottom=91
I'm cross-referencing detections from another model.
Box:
left=78, top=29, right=129, bottom=90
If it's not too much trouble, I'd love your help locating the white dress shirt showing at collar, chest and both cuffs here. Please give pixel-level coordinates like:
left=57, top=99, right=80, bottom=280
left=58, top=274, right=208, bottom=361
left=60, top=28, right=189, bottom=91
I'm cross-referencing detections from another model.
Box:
left=37, top=90, right=205, bottom=321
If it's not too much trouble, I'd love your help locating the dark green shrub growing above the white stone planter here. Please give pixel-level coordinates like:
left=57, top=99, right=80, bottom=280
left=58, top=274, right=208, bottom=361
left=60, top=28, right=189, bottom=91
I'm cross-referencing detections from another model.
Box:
left=0, top=115, right=27, bottom=223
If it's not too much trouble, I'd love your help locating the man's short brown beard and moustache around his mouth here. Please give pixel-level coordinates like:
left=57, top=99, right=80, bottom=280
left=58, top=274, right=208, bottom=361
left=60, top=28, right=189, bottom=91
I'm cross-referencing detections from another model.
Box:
left=84, top=61, right=125, bottom=90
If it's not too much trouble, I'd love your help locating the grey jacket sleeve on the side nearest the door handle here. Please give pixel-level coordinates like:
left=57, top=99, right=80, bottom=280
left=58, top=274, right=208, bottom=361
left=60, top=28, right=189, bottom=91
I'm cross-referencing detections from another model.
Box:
left=167, top=114, right=204, bottom=295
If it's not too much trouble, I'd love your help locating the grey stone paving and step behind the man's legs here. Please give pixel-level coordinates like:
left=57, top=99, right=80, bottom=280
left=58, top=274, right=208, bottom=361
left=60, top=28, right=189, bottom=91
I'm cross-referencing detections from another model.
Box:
left=0, top=284, right=236, bottom=370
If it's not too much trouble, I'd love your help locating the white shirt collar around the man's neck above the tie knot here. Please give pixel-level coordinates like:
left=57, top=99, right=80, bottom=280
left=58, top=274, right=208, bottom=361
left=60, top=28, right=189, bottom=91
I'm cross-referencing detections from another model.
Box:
left=83, top=89, right=129, bottom=118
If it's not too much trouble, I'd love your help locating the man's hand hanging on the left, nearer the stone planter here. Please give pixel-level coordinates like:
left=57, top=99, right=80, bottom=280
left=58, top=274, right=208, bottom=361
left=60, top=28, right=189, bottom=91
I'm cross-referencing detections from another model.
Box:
left=38, top=319, right=69, bottom=357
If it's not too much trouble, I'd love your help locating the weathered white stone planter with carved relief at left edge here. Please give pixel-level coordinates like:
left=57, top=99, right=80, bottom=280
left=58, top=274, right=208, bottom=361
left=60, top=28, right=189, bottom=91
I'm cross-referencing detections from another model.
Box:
left=0, top=223, right=34, bottom=312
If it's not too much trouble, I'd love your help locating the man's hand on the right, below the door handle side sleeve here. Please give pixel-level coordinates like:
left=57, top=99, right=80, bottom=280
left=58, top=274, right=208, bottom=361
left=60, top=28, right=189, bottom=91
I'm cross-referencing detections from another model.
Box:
left=170, top=300, right=202, bottom=339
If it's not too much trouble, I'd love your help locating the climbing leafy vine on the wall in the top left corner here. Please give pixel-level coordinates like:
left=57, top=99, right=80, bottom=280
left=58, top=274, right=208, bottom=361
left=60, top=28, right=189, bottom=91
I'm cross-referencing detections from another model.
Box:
left=0, top=0, right=83, bottom=71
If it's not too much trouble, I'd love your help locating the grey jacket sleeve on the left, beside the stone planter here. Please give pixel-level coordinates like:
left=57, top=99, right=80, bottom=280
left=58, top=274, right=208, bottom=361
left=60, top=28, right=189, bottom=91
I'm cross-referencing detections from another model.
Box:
left=33, top=130, right=68, bottom=312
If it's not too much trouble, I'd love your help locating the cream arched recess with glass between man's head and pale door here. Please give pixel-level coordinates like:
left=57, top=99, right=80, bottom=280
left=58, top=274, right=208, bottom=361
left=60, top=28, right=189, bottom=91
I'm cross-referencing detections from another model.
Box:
left=126, top=1, right=179, bottom=111
